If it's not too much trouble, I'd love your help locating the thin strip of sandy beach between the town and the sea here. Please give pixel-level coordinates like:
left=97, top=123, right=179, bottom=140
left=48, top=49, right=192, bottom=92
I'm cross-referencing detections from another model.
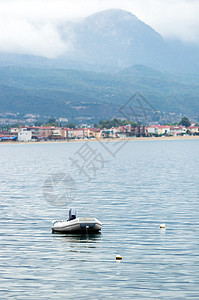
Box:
left=0, top=135, right=199, bottom=145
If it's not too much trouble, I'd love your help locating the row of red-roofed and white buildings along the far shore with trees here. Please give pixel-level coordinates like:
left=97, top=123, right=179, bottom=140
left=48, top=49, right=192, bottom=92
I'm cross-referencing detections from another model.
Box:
left=0, top=123, right=199, bottom=143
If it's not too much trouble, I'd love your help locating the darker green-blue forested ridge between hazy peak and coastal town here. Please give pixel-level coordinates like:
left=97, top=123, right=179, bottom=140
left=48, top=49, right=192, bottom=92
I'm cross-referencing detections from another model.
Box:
left=0, top=65, right=199, bottom=121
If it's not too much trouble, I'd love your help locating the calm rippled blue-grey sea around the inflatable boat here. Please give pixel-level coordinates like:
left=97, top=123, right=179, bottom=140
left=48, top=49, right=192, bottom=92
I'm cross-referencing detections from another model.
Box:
left=0, top=140, right=199, bottom=300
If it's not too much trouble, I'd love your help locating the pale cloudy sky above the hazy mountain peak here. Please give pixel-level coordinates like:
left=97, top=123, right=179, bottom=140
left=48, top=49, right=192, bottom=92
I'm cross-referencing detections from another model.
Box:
left=0, top=0, right=199, bottom=58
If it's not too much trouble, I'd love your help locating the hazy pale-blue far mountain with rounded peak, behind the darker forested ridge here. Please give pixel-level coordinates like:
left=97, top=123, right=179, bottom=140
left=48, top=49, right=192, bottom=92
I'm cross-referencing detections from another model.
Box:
left=0, top=9, right=199, bottom=73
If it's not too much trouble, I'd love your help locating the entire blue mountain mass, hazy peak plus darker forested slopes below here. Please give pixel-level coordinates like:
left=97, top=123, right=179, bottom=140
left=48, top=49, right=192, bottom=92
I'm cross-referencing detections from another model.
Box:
left=0, top=9, right=199, bottom=121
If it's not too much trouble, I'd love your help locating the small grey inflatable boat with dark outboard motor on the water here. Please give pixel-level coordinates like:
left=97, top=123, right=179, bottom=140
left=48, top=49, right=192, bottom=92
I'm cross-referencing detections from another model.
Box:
left=52, top=209, right=102, bottom=233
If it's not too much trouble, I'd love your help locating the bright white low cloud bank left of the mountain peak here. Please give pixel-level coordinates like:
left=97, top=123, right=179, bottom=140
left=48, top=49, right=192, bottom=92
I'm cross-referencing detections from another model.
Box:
left=0, top=19, right=69, bottom=58
